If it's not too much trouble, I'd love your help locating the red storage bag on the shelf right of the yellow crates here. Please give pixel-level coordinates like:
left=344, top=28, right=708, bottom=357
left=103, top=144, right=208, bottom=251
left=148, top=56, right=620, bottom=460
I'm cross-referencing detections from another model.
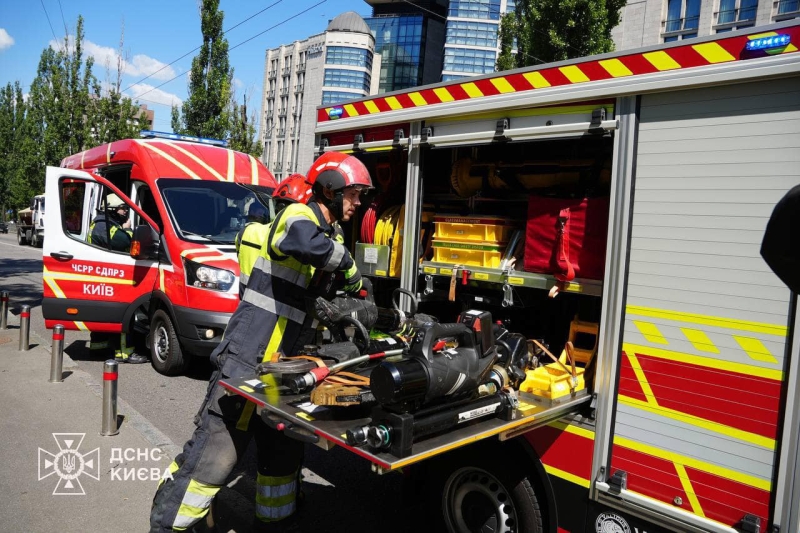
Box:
left=524, top=196, right=609, bottom=281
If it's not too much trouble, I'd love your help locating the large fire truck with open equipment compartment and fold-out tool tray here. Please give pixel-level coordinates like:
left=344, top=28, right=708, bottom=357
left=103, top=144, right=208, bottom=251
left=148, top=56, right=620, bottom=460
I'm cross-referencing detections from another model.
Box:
left=219, top=20, right=800, bottom=533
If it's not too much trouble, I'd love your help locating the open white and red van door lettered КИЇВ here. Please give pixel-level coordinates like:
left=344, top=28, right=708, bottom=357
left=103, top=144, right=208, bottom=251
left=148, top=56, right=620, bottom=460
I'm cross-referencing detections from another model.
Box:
left=42, top=167, right=158, bottom=333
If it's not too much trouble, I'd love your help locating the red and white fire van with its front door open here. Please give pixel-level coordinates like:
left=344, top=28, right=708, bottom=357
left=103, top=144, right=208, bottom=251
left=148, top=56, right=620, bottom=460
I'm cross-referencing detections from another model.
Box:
left=42, top=132, right=275, bottom=375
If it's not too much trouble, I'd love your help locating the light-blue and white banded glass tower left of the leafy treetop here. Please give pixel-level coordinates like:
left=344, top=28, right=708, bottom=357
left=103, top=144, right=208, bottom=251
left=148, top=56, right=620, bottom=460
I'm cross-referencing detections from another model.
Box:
left=441, top=0, right=516, bottom=81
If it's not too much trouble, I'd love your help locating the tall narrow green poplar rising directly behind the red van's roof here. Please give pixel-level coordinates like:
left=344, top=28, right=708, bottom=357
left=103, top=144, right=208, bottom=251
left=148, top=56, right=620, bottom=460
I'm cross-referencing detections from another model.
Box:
left=179, top=0, right=233, bottom=139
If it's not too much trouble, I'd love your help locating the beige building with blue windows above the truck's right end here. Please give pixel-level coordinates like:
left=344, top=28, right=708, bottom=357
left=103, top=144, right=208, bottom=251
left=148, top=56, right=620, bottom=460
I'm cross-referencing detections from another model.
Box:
left=611, top=0, right=800, bottom=50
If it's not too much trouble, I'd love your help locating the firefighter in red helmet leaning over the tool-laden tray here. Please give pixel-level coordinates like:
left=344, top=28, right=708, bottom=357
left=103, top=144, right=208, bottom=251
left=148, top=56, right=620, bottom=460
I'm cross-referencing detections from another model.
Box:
left=150, top=152, right=372, bottom=531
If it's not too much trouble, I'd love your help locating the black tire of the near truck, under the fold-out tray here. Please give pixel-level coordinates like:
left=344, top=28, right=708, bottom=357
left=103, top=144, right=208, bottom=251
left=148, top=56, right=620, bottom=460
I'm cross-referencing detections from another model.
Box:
left=428, top=445, right=544, bottom=533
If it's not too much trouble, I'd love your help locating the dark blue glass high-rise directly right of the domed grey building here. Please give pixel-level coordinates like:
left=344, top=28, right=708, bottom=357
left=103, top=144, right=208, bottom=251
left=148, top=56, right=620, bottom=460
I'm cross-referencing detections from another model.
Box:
left=364, top=0, right=447, bottom=93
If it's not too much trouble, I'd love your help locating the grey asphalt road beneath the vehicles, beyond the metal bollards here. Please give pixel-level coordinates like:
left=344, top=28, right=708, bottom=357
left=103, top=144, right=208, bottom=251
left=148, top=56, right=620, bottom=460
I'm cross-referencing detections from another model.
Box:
left=0, top=225, right=430, bottom=533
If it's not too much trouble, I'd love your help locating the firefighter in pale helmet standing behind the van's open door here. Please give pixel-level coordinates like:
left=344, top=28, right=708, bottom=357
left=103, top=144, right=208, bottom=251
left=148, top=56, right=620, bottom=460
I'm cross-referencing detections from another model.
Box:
left=87, top=193, right=149, bottom=364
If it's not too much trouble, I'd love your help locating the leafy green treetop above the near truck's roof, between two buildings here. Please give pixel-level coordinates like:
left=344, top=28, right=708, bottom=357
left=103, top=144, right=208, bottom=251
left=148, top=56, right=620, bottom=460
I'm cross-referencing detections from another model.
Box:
left=497, top=0, right=626, bottom=70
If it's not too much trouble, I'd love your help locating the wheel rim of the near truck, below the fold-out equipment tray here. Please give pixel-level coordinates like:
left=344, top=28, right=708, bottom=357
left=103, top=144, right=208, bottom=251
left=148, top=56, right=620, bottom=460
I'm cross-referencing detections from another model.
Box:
left=443, top=467, right=517, bottom=533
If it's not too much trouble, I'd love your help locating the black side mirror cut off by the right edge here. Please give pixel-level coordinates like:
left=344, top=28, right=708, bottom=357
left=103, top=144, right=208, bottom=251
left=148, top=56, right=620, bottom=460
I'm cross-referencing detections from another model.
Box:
left=761, top=185, right=800, bottom=293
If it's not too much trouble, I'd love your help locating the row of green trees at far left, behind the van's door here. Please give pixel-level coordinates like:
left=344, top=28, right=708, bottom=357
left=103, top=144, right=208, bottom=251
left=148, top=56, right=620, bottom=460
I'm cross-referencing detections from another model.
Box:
left=0, top=17, right=141, bottom=209
